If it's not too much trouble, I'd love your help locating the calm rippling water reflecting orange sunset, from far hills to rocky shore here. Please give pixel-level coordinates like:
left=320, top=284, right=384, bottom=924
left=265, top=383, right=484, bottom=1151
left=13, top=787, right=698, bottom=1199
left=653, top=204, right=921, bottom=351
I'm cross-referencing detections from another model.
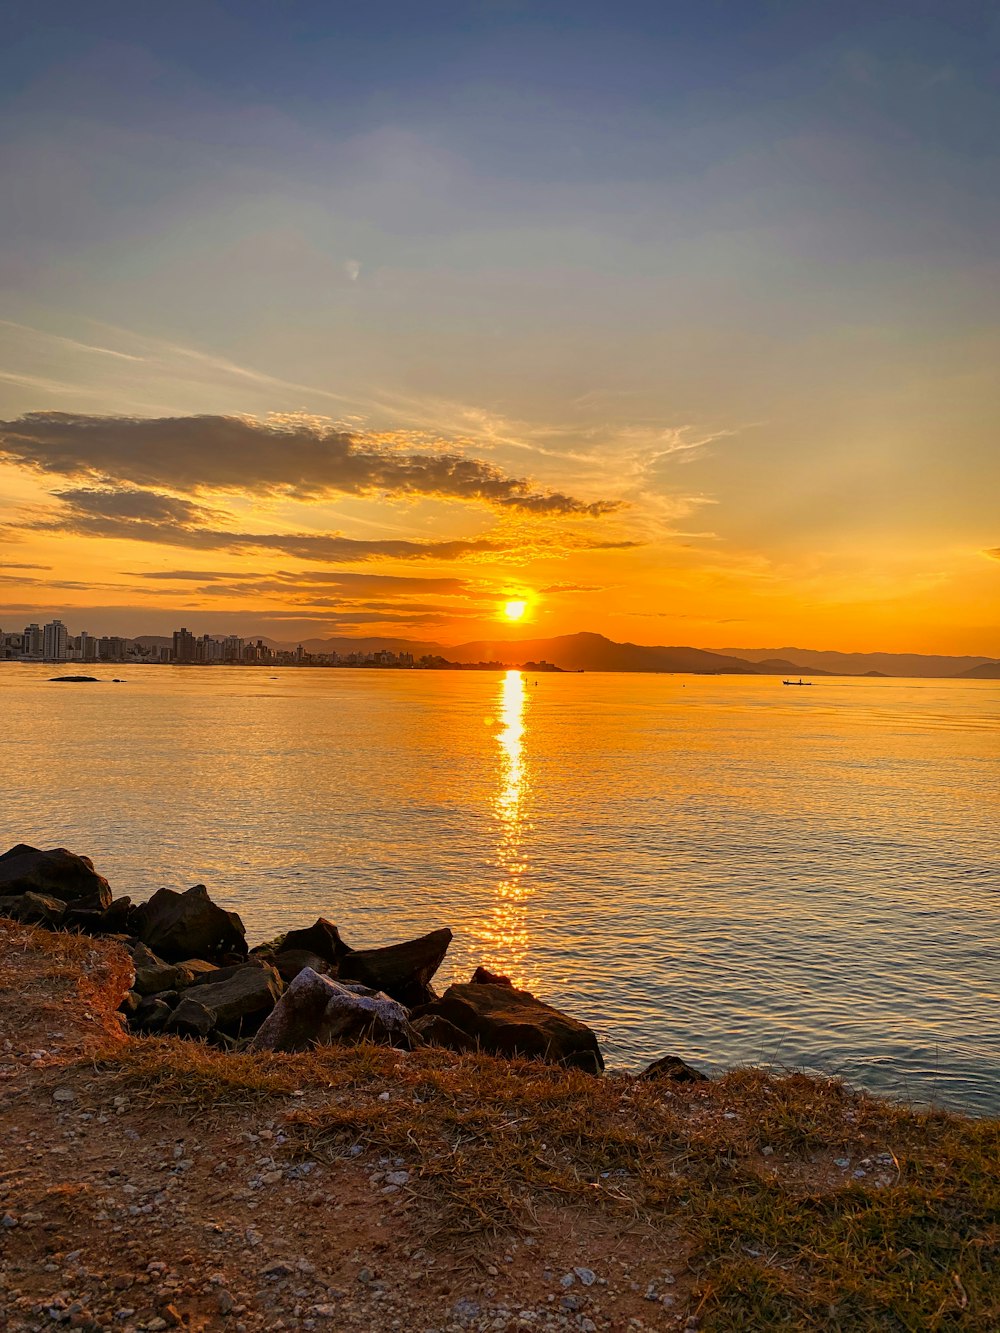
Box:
left=0, top=664, right=1000, bottom=1112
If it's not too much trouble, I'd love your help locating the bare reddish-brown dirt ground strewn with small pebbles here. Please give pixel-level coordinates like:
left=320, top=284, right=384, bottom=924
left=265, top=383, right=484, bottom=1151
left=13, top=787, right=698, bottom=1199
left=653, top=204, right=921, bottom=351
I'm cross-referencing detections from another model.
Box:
left=0, top=922, right=699, bottom=1333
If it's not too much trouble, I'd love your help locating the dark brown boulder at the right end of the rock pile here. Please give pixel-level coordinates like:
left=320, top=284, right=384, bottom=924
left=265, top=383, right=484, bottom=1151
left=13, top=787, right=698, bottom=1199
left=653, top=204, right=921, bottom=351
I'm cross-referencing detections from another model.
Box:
left=420, top=982, right=604, bottom=1073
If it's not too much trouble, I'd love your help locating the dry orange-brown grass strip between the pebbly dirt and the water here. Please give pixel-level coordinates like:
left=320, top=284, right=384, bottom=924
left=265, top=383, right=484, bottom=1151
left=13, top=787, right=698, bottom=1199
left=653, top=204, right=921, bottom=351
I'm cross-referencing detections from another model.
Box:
left=98, top=1040, right=1000, bottom=1330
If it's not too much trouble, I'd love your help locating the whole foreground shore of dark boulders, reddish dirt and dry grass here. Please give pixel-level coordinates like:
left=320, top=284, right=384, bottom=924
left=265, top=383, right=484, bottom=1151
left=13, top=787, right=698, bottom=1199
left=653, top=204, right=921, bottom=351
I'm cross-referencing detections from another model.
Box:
left=0, top=846, right=1000, bottom=1333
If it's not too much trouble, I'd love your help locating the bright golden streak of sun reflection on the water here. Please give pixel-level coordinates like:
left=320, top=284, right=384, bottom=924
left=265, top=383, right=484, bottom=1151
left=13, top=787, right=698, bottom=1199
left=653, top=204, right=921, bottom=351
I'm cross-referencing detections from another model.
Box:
left=484, top=670, right=529, bottom=984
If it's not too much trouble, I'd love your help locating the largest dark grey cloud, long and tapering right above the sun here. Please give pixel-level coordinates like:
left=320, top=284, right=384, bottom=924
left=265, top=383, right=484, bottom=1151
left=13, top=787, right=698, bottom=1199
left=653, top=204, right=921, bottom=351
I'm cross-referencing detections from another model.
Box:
left=0, top=412, right=620, bottom=517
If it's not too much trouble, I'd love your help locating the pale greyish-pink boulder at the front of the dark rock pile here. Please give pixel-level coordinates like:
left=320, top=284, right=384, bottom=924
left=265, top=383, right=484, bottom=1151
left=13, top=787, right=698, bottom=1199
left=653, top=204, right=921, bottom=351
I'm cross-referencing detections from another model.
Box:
left=251, top=968, right=411, bottom=1050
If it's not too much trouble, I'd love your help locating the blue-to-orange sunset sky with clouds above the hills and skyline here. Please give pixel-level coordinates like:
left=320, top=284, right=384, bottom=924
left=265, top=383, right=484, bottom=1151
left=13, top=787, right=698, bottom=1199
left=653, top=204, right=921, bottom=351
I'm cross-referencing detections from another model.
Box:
left=0, top=0, right=1000, bottom=656
